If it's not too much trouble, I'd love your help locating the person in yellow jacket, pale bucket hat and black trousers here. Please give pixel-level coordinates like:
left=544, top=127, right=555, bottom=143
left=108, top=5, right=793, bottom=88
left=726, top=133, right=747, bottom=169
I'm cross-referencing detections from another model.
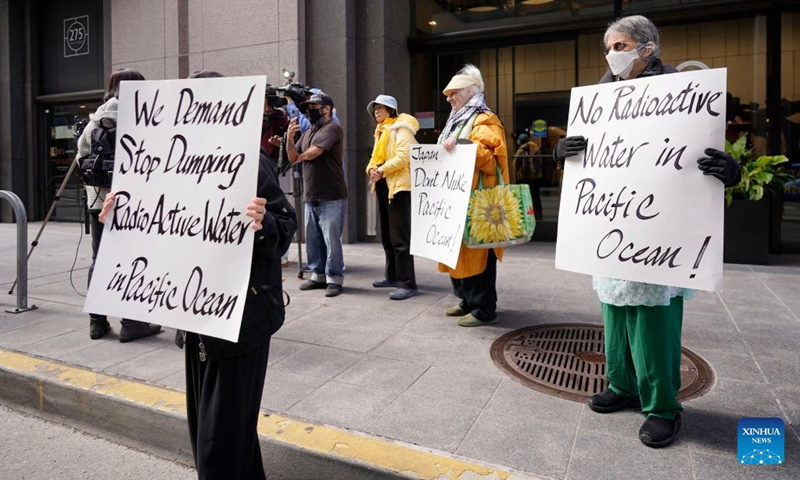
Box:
left=367, top=95, right=419, bottom=300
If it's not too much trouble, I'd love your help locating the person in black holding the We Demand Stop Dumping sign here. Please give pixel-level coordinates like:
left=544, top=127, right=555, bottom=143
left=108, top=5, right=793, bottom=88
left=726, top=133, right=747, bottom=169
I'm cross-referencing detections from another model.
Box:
left=100, top=71, right=297, bottom=479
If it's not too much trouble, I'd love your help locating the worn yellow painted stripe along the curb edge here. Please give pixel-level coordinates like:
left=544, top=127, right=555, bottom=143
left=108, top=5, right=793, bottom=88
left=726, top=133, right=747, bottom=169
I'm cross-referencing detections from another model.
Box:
left=0, top=349, right=513, bottom=480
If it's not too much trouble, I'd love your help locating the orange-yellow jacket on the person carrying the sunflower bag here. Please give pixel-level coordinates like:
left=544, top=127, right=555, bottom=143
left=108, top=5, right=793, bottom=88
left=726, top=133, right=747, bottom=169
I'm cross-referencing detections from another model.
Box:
left=439, top=113, right=508, bottom=278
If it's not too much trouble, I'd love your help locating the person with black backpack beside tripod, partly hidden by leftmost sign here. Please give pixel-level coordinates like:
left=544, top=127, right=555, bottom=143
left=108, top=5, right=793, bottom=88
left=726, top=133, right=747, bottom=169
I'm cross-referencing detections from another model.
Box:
left=75, top=68, right=161, bottom=343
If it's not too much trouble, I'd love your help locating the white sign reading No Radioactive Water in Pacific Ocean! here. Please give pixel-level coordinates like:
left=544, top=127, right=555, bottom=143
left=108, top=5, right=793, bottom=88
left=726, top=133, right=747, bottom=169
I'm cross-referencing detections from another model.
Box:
left=556, top=69, right=727, bottom=291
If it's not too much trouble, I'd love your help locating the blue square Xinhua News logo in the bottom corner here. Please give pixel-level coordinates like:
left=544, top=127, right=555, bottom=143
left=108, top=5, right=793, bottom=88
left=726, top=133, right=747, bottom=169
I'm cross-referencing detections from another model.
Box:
left=738, top=418, right=786, bottom=465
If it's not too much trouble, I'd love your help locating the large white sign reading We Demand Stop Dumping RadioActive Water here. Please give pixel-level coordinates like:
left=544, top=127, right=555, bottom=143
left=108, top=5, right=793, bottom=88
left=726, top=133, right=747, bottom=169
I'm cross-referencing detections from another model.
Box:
left=84, top=76, right=266, bottom=342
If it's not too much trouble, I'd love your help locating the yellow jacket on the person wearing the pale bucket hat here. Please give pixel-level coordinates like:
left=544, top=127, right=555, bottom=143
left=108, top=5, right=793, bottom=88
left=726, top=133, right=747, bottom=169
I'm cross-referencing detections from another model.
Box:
left=367, top=113, right=419, bottom=200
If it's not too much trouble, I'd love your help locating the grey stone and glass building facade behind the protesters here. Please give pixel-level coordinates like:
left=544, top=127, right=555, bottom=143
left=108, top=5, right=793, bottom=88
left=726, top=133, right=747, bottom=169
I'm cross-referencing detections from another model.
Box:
left=0, top=0, right=800, bottom=253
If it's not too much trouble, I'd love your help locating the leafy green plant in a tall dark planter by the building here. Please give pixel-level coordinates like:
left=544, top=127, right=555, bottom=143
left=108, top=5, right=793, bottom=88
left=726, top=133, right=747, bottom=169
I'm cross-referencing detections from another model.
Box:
left=723, top=135, right=791, bottom=265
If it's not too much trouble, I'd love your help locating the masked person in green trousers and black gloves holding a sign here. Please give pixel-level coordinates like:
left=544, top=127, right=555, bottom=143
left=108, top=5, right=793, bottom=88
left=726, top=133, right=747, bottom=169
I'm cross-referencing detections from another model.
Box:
left=553, top=15, right=740, bottom=448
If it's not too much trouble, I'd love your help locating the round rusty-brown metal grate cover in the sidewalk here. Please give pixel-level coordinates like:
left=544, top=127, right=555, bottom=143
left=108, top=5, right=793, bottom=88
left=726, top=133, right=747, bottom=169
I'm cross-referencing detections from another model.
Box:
left=491, top=323, right=714, bottom=402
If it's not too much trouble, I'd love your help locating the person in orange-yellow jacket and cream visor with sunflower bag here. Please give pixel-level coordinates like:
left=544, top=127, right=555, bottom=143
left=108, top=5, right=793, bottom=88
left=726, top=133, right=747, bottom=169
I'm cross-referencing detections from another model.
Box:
left=438, top=64, right=508, bottom=327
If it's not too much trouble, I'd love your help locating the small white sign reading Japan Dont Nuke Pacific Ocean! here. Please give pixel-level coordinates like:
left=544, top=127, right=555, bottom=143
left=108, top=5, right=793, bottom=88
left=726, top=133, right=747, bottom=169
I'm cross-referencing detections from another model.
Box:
left=411, top=145, right=478, bottom=268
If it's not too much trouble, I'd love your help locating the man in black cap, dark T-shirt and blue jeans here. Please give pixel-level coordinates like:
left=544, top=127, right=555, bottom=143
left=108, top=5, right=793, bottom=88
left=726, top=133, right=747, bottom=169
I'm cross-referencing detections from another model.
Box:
left=286, top=94, right=347, bottom=297
